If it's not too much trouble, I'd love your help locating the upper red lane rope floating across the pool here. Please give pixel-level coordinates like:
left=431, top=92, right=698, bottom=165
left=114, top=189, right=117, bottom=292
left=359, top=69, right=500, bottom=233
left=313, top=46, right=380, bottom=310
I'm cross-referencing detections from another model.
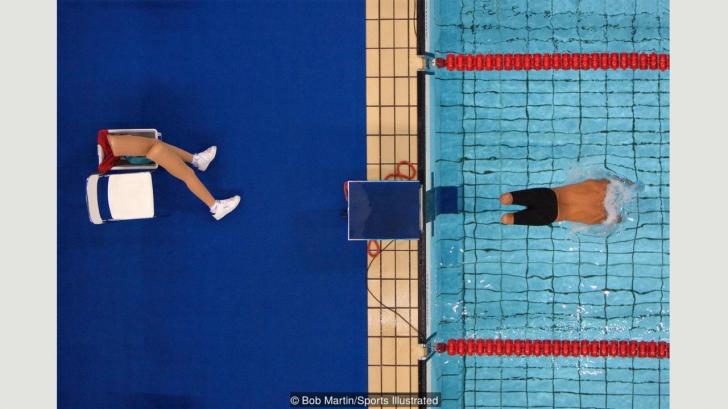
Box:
left=435, top=53, right=670, bottom=71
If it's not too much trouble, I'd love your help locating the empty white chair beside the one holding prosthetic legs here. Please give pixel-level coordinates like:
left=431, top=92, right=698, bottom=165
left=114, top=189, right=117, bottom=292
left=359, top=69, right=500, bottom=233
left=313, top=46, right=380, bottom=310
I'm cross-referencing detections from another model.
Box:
left=86, top=172, right=154, bottom=224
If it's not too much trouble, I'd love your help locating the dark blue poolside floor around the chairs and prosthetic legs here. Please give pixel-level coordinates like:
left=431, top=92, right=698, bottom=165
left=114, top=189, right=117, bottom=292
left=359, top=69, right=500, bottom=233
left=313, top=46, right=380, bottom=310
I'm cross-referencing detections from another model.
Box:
left=58, top=0, right=367, bottom=409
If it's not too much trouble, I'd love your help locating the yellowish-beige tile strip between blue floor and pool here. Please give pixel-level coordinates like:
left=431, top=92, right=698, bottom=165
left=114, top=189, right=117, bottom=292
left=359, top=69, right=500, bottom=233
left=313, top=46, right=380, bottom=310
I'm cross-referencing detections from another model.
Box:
left=366, top=0, right=423, bottom=404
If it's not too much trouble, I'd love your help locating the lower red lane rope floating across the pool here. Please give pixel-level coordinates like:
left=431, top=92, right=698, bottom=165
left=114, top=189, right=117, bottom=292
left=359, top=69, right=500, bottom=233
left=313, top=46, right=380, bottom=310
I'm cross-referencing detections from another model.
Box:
left=435, top=338, right=670, bottom=359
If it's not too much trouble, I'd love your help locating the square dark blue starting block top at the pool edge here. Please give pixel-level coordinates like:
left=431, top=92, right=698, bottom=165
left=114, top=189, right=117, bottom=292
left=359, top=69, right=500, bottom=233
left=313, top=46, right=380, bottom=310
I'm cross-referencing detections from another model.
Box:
left=348, top=182, right=420, bottom=240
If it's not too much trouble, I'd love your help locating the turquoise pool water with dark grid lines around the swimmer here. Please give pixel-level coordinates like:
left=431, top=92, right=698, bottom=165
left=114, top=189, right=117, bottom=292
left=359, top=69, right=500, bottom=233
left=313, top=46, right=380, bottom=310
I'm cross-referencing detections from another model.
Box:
left=427, top=0, right=669, bottom=408
